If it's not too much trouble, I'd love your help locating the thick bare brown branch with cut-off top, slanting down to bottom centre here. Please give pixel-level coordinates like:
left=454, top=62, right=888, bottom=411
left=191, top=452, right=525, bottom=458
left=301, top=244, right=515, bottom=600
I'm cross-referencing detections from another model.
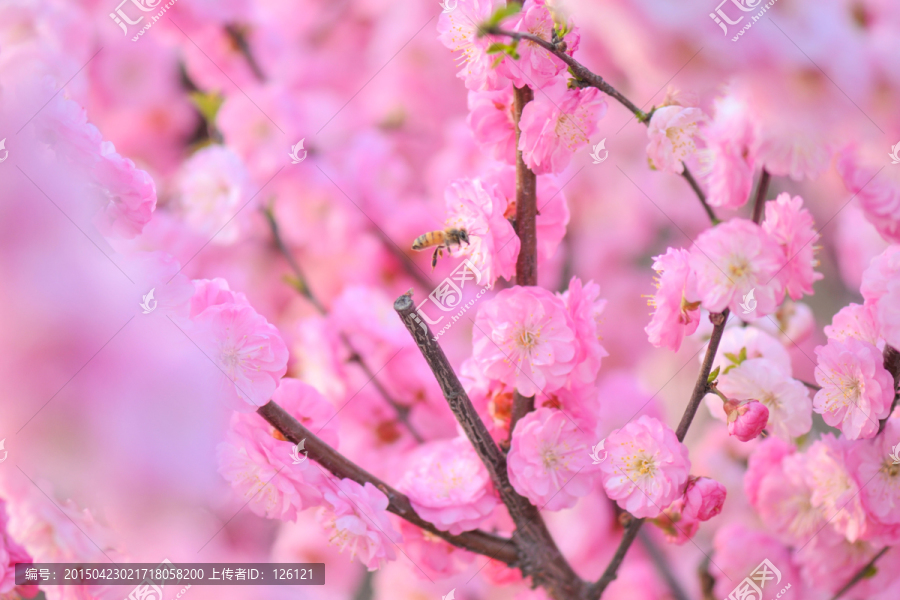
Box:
left=394, top=294, right=586, bottom=600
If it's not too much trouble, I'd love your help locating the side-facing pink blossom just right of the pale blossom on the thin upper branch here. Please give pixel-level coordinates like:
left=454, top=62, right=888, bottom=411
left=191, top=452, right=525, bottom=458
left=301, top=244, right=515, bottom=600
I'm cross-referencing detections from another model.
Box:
left=701, top=96, right=754, bottom=208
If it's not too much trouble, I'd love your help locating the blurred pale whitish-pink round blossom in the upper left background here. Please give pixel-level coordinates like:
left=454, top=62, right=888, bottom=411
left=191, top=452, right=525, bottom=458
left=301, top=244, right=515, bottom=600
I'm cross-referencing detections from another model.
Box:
left=178, top=145, right=252, bottom=244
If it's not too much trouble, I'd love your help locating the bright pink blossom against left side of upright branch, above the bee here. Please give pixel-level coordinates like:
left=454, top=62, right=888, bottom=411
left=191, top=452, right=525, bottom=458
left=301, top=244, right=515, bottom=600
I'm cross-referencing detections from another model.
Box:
left=466, top=85, right=516, bottom=165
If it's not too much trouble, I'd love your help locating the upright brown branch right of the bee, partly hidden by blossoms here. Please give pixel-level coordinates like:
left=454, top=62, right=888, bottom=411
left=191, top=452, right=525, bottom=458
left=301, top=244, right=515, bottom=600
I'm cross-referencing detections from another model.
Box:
left=504, top=86, right=537, bottom=448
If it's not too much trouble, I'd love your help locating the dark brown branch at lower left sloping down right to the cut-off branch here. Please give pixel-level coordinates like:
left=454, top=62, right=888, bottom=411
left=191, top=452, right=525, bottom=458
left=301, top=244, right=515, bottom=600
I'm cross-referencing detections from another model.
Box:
left=256, top=400, right=519, bottom=567
